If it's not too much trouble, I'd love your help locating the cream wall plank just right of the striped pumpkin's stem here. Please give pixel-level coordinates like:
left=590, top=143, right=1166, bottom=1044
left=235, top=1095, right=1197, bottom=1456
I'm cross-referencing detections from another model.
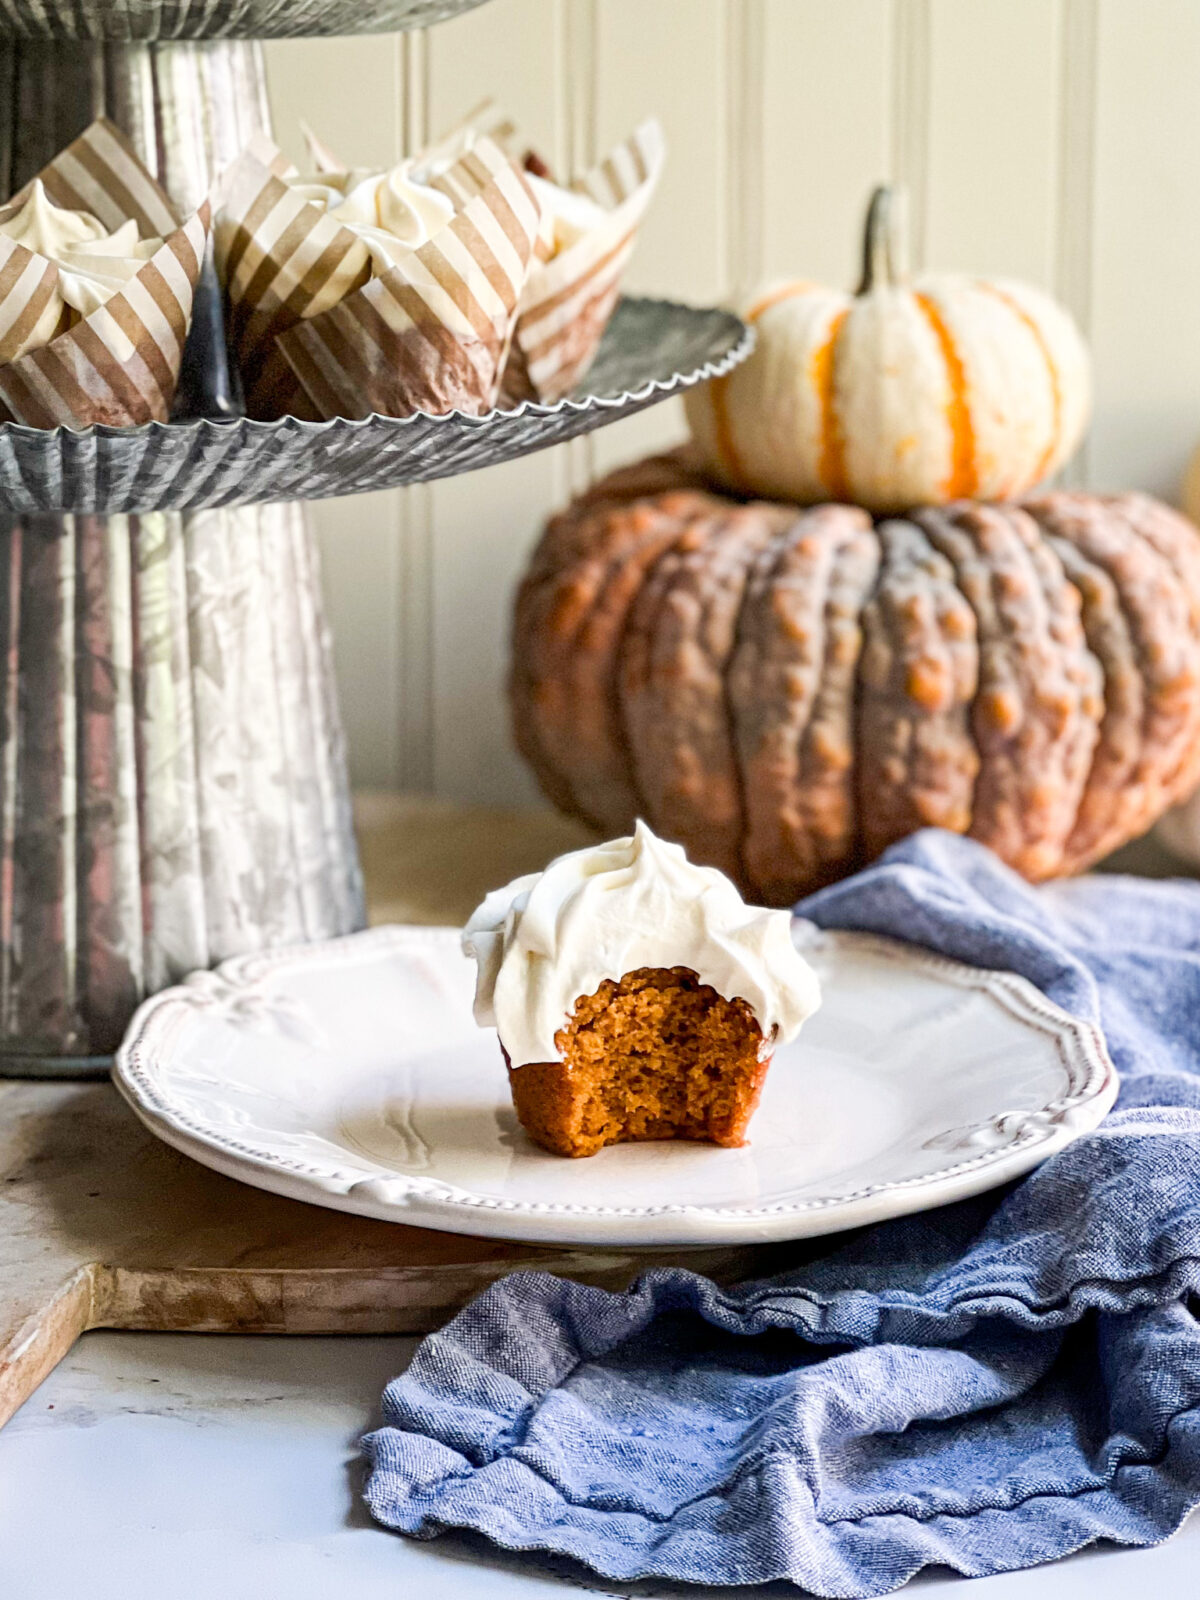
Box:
left=922, top=0, right=1061, bottom=288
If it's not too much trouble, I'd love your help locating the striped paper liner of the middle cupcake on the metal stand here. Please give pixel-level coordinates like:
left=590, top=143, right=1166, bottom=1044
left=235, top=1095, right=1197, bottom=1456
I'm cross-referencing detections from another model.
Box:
left=214, top=139, right=541, bottom=419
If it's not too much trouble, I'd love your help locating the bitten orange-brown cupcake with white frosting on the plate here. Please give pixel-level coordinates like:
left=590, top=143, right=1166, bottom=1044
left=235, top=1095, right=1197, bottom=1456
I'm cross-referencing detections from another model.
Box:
left=462, top=822, right=821, bottom=1155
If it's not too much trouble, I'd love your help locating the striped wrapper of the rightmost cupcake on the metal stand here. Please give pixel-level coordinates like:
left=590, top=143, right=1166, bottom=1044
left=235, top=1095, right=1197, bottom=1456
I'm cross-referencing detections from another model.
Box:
left=501, top=118, right=666, bottom=405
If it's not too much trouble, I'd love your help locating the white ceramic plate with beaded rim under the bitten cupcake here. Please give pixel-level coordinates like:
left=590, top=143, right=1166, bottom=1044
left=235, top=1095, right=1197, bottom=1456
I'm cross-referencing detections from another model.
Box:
left=115, top=922, right=1117, bottom=1246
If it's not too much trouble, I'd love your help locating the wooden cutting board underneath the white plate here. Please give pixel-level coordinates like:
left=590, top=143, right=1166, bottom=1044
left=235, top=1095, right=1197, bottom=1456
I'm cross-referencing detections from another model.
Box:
left=0, top=798, right=784, bottom=1424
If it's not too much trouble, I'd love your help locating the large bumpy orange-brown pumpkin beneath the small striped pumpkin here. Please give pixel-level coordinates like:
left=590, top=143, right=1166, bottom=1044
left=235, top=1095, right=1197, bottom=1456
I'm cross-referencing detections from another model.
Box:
left=510, top=456, right=1200, bottom=904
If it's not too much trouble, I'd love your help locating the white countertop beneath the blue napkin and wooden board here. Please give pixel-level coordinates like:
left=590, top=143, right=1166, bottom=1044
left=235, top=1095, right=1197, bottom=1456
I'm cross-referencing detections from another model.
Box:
left=0, top=1333, right=1200, bottom=1600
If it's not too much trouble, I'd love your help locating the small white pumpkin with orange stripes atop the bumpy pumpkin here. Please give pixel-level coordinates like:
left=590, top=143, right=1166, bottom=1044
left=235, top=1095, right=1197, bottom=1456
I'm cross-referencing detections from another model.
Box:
left=686, top=189, right=1091, bottom=512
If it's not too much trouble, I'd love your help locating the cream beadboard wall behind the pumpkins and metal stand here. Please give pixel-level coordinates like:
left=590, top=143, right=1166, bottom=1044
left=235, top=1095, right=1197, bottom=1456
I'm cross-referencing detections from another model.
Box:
left=267, top=0, right=1200, bottom=803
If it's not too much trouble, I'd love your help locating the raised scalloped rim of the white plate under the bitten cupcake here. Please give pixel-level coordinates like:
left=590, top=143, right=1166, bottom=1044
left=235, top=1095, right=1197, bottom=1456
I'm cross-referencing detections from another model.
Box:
left=114, top=923, right=1118, bottom=1248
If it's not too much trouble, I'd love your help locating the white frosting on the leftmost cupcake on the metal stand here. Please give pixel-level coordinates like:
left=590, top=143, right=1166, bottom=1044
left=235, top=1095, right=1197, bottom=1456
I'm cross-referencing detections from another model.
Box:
left=0, top=178, right=162, bottom=340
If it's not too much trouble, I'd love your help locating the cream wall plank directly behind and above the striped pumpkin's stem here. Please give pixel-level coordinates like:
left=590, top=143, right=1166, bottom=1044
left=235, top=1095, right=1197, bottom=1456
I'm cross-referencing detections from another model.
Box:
left=757, top=0, right=894, bottom=288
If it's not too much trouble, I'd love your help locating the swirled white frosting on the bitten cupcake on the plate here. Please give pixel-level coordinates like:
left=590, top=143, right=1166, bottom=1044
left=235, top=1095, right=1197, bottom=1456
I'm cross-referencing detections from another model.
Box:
left=462, top=822, right=821, bottom=1067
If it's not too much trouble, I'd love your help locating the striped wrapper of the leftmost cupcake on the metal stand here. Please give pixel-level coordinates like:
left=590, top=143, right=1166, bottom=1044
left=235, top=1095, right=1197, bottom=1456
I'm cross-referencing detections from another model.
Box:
left=0, top=118, right=210, bottom=427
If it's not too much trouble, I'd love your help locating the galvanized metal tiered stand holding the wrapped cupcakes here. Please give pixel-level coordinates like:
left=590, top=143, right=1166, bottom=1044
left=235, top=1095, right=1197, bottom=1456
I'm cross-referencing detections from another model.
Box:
left=0, top=0, right=749, bottom=1077
